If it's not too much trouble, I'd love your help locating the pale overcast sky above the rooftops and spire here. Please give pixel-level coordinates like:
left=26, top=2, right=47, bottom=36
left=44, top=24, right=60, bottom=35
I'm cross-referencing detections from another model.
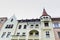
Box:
left=0, top=0, right=60, bottom=19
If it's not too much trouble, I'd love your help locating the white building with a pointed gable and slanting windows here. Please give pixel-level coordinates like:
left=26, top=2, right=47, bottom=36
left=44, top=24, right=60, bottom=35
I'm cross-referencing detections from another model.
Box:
left=0, top=15, right=17, bottom=40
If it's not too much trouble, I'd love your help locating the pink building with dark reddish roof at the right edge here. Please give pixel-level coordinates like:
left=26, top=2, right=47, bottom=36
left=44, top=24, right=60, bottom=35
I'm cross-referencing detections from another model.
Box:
left=52, top=18, right=60, bottom=40
